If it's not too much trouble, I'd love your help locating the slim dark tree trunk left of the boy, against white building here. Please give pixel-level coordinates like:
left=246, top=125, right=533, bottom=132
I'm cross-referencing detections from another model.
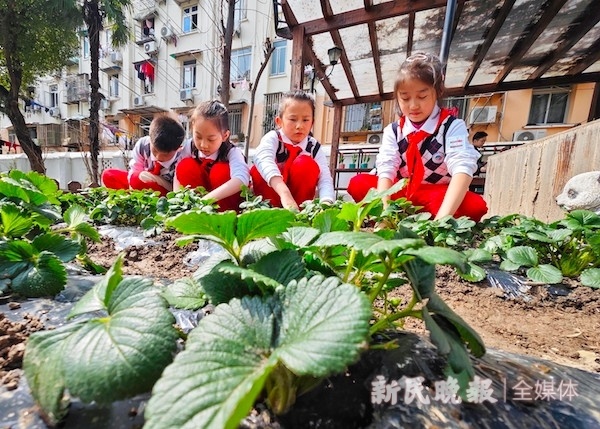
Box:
left=84, top=0, right=102, bottom=187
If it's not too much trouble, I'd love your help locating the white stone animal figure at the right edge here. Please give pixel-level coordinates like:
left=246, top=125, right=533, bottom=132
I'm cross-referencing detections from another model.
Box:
left=556, top=171, right=600, bottom=214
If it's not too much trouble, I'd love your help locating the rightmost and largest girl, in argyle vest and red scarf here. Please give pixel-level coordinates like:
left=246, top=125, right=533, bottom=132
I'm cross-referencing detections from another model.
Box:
left=348, top=53, right=487, bottom=221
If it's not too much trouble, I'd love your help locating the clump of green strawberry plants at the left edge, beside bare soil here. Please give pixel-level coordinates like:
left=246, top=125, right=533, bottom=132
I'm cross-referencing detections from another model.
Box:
left=0, top=170, right=100, bottom=297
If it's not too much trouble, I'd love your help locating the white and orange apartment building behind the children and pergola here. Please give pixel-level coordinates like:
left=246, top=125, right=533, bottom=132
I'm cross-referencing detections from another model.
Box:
left=0, top=0, right=598, bottom=153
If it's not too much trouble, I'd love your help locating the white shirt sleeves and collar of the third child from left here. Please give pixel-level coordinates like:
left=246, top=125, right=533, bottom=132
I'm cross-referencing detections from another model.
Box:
left=254, top=130, right=335, bottom=201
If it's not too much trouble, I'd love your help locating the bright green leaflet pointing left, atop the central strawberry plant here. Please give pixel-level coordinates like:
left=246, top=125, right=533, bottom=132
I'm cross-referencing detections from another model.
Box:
left=166, top=211, right=237, bottom=246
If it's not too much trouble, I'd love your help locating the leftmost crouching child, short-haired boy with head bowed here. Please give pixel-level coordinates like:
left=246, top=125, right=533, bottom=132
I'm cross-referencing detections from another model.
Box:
left=102, top=115, right=185, bottom=195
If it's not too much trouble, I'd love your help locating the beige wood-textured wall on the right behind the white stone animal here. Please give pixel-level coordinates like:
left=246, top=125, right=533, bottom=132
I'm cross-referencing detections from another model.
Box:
left=484, top=120, right=600, bottom=222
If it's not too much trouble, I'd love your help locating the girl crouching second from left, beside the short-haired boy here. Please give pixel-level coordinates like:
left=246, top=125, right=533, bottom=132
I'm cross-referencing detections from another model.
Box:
left=174, top=100, right=250, bottom=211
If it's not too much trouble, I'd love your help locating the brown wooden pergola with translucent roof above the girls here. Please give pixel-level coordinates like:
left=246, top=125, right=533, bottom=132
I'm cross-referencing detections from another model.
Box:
left=274, top=0, right=600, bottom=170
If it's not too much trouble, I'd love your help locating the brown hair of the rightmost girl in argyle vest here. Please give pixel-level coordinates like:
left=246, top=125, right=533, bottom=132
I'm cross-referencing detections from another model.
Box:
left=394, top=52, right=446, bottom=100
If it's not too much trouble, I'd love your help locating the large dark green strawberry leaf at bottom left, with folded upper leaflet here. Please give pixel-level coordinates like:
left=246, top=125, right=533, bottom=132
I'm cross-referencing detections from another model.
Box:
left=23, top=254, right=178, bottom=426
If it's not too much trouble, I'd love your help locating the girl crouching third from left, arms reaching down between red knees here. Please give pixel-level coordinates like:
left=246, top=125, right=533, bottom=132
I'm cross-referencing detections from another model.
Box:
left=250, top=91, right=335, bottom=210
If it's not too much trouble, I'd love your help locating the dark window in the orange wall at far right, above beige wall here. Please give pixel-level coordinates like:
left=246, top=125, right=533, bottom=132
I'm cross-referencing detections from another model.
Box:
left=527, top=87, right=570, bottom=125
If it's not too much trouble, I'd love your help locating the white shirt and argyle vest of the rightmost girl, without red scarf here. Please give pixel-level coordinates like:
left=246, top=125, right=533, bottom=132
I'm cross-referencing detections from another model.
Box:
left=376, top=106, right=481, bottom=183
